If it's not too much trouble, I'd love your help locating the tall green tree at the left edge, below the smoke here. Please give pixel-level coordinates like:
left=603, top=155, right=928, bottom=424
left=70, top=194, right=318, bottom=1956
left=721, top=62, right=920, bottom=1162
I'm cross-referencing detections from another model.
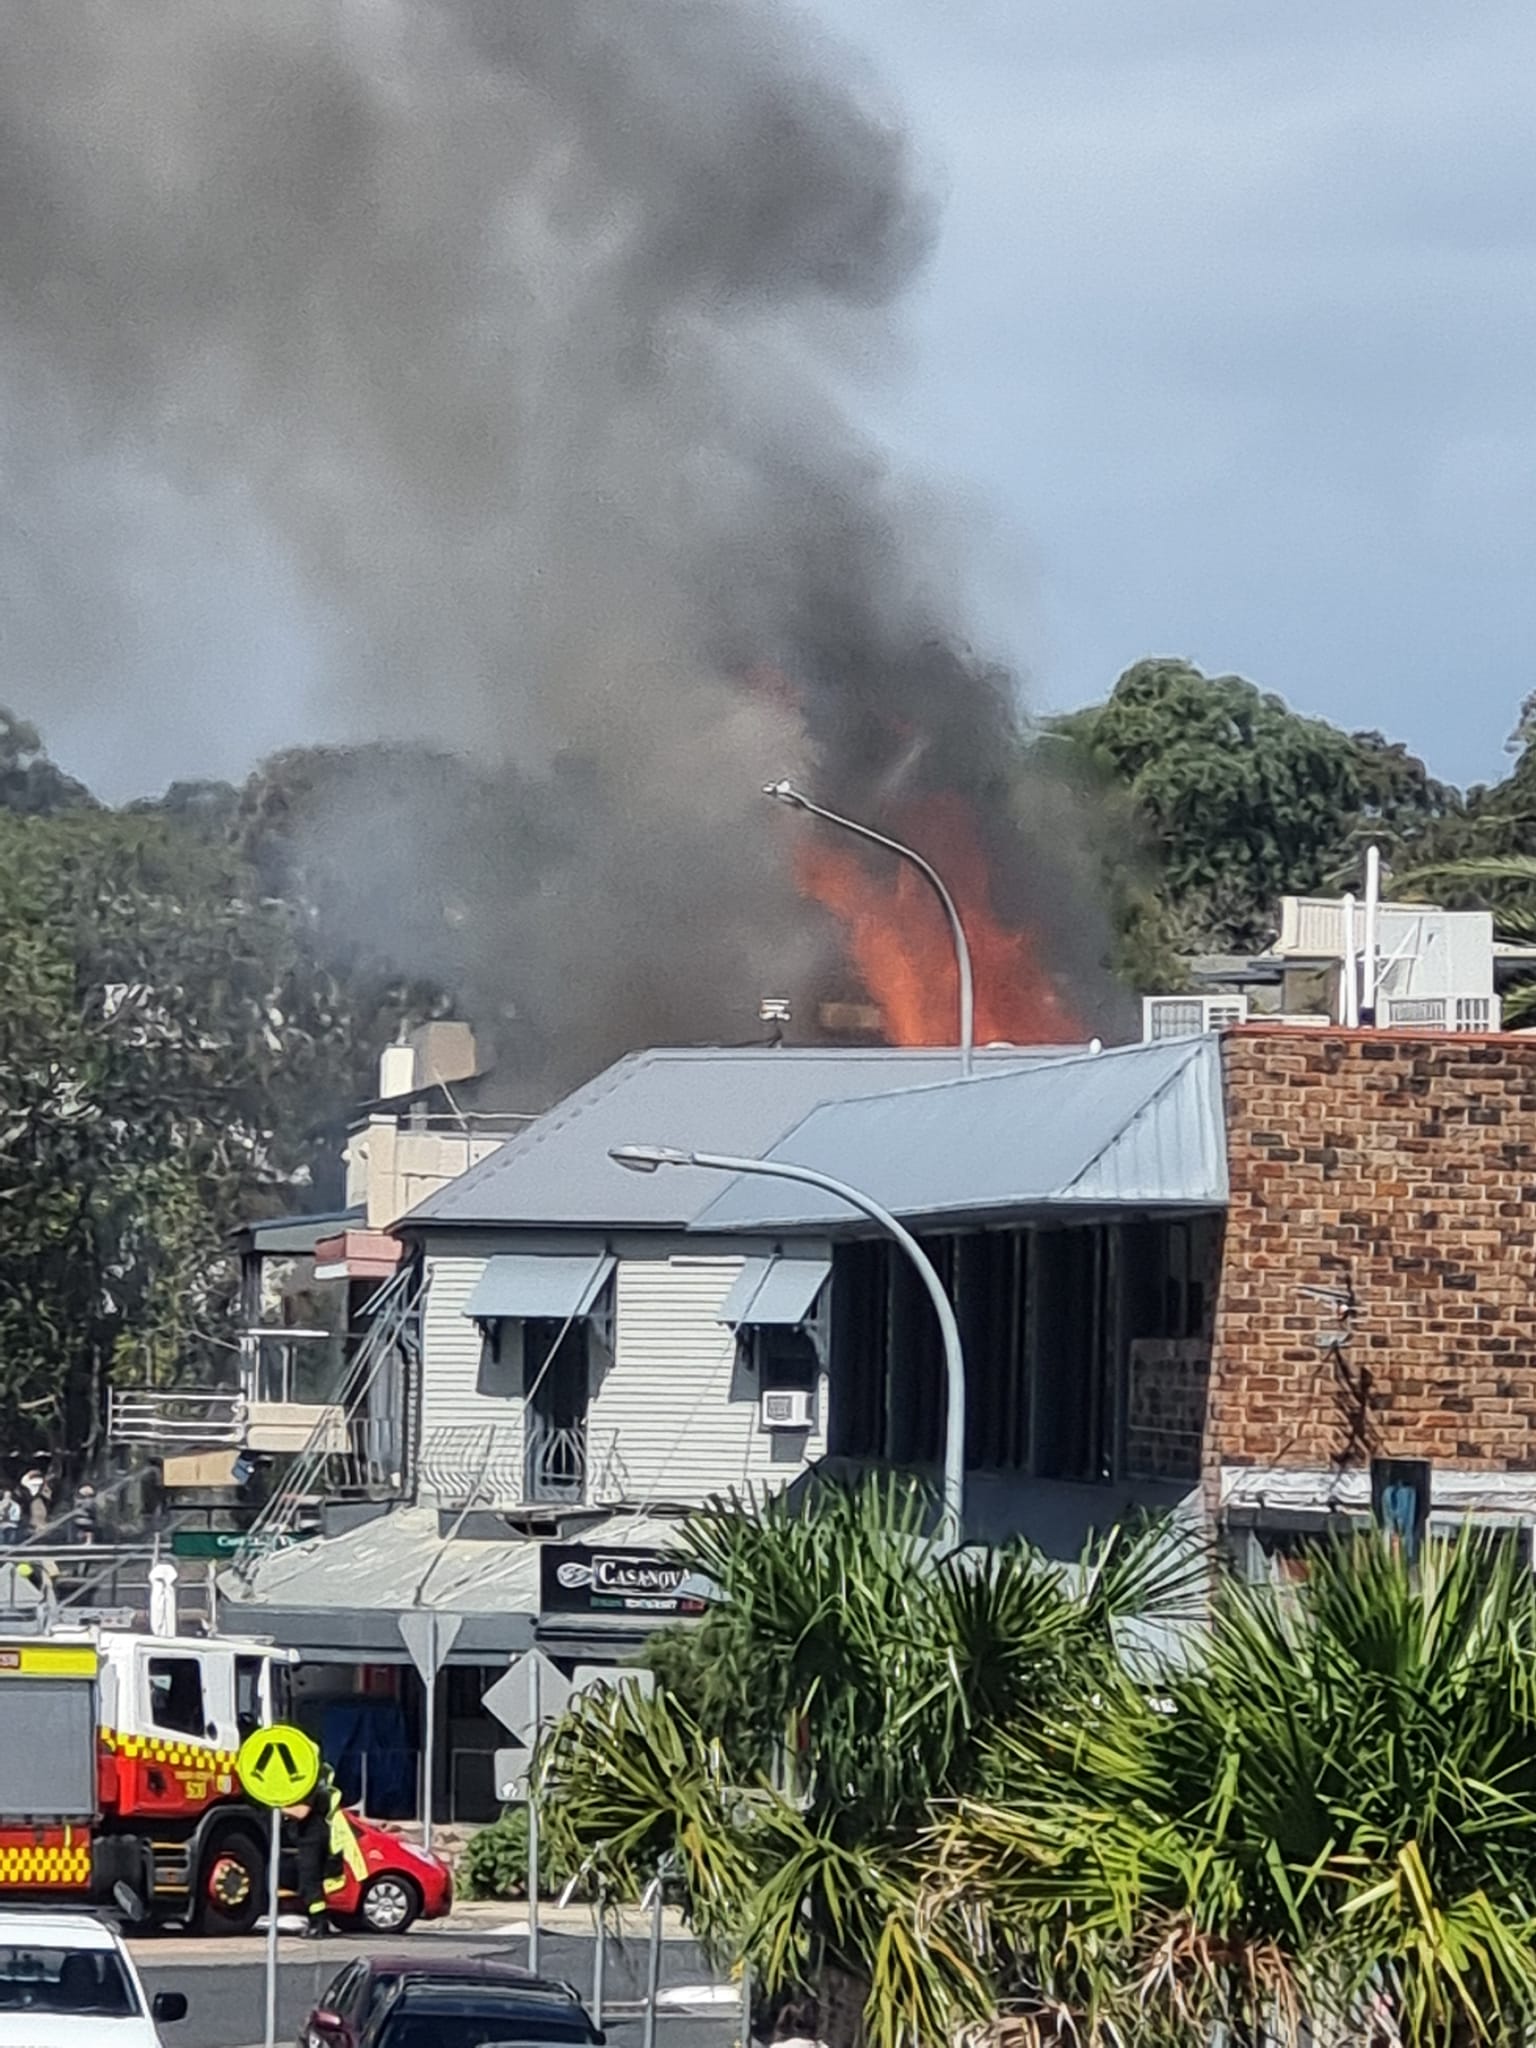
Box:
left=0, top=807, right=403, bottom=1454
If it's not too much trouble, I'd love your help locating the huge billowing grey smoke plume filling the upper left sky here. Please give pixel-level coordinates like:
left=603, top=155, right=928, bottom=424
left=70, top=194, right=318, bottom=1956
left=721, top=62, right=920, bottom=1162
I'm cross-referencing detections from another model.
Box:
left=0, top=0, right=1122, bottom=1079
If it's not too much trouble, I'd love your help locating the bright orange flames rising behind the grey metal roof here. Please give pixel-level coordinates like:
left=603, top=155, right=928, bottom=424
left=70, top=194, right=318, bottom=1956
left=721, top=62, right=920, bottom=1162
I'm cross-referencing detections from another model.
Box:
left=795, top=797, right=1081, bottom=1044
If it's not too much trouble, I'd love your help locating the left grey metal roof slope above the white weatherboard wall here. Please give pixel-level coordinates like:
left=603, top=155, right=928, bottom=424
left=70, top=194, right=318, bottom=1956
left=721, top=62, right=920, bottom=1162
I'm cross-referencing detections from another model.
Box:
left=397, top=1047, right=1065, bottom=1231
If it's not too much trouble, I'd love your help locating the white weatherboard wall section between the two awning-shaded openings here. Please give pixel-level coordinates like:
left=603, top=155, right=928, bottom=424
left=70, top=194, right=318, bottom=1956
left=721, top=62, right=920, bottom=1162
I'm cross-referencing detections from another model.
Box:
left=588, top=1257, right=825, bottom=1501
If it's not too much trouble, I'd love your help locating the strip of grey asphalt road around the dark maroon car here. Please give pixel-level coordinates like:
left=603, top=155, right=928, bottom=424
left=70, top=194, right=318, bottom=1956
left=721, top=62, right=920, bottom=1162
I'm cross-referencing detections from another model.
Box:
left=133, top=1909, right=739, bottom=2048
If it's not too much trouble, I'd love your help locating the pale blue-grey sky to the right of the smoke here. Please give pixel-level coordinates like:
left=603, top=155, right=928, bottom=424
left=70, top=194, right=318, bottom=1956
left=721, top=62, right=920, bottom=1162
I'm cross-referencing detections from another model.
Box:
left=817, top=0, right=1536, bottom=780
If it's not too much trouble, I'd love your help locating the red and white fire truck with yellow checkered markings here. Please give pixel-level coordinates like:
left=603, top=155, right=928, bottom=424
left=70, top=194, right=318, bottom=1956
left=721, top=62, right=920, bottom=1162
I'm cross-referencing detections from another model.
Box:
left=0, top=1628, right=293, bottom=1933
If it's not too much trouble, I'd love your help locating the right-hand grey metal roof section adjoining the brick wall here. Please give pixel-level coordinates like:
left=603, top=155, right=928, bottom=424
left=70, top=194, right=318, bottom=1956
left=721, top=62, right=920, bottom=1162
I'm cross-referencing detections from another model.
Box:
left=680, top=1036, right=1227, bottom=1231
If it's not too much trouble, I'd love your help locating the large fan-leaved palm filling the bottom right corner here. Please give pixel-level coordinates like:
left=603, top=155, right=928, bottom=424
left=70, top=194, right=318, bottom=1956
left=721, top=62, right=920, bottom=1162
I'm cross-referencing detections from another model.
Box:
left=930, top=1538, right=1536, bottom=2048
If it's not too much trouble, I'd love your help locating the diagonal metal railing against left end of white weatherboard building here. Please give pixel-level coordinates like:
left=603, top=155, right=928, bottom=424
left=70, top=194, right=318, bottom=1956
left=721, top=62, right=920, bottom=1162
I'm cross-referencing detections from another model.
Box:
left=231, top=1266, right=422, bottom=1577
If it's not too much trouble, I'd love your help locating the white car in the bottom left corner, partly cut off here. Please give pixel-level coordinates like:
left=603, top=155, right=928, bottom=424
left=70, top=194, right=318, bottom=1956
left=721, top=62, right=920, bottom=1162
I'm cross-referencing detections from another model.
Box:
left=0, top=1911, right=186, bottom=2048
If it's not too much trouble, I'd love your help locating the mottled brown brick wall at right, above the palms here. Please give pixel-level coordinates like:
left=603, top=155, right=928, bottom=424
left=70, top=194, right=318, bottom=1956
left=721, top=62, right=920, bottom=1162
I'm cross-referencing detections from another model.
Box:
left=1206, top=1026, right=1536, bottom=1487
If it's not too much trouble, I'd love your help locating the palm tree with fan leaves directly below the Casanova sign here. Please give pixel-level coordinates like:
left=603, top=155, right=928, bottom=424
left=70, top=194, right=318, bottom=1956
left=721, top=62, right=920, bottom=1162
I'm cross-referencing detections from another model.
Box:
left=541, top=1479, right=1198, bottom=2048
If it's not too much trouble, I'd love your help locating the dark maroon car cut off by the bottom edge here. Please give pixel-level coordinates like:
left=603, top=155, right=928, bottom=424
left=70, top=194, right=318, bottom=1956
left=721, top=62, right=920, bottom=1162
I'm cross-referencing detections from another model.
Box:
left=299, top=1956, right=602, bottom=2048
